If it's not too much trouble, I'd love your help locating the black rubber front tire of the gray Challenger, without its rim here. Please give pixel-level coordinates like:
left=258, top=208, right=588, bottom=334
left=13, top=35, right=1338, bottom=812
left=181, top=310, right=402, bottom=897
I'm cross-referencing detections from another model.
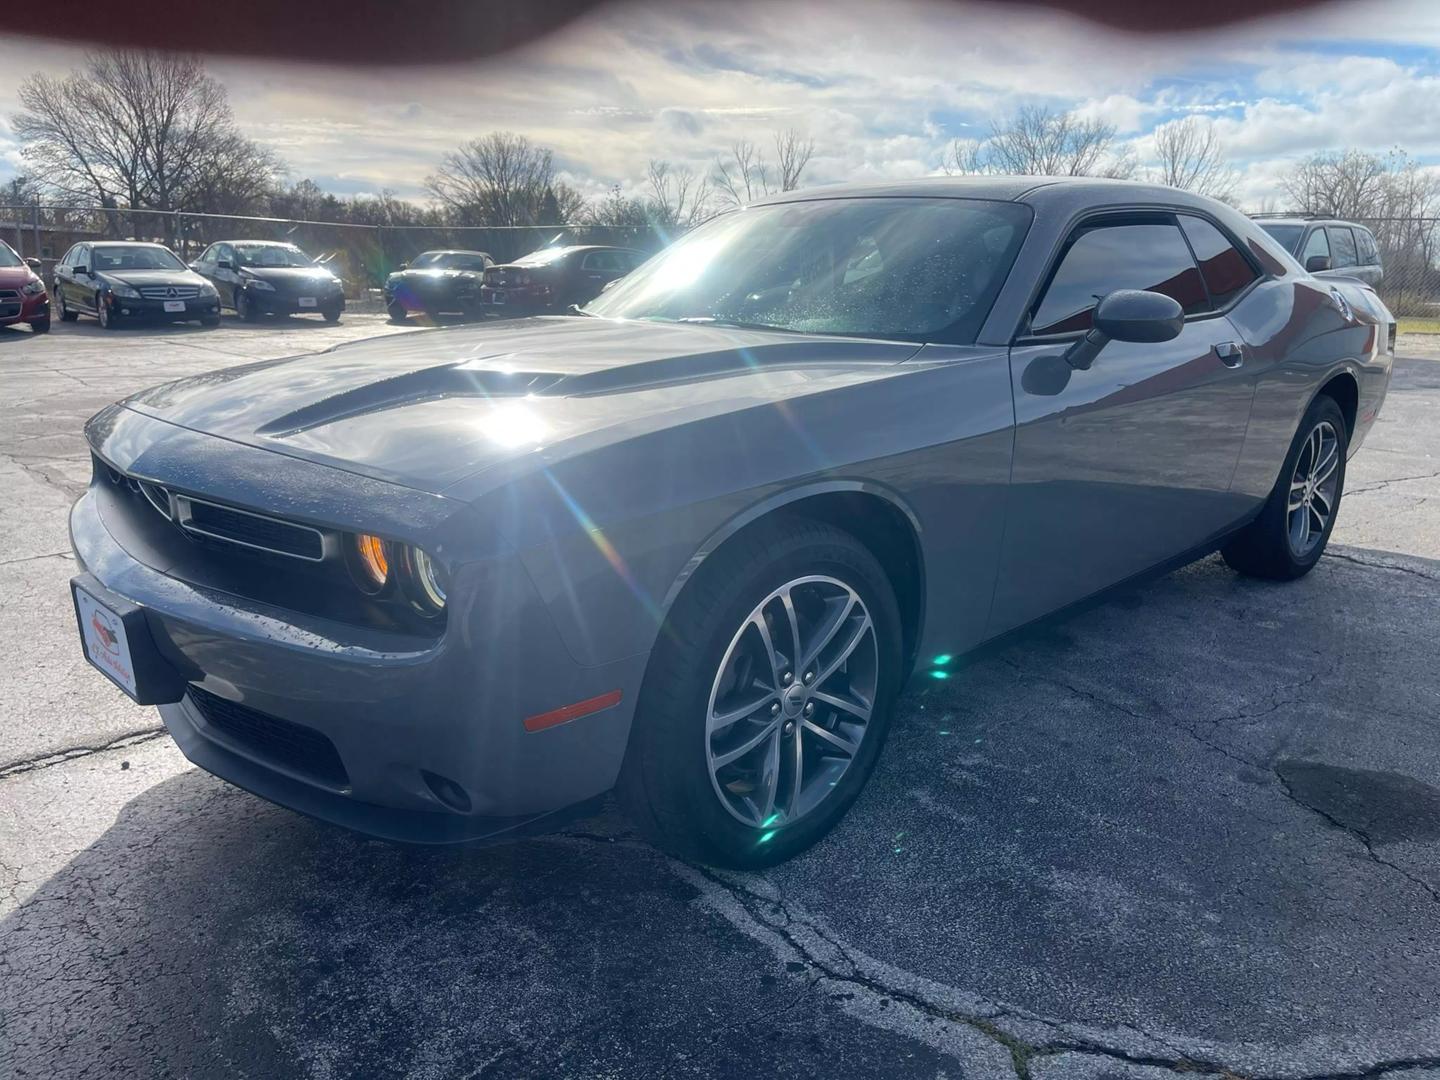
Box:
left=618, top=518, right=903, bottom=868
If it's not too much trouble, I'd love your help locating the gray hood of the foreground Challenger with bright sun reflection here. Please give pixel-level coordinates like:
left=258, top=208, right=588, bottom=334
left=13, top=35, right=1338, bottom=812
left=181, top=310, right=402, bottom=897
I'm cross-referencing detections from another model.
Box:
left=125, top=317, right=919, bottom=492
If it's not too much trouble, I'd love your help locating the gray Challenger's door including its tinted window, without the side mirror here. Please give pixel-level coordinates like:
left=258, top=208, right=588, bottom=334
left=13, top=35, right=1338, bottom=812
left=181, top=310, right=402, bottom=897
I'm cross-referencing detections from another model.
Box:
left=989, top=215, right=1257, bottom=634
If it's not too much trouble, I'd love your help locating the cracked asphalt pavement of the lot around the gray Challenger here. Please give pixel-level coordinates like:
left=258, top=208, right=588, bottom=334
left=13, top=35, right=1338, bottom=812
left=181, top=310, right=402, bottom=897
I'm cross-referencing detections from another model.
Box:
left=0, top=317, right=1440, bottom=1080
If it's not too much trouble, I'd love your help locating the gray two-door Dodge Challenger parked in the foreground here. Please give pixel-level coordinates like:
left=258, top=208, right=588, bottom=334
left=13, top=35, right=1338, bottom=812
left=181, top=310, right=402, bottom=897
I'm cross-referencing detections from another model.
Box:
left=71, top=177, right=1395, bottom=867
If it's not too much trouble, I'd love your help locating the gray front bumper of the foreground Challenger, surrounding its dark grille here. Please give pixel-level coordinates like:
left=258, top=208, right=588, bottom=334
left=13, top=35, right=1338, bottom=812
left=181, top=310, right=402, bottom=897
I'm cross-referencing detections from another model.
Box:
left=71, top=413, right=645, bottom=844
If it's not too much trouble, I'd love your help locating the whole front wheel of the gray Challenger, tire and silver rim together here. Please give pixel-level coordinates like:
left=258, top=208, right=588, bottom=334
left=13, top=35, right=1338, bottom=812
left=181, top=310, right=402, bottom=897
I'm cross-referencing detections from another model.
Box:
left=618, top=518, right=901, bottom=868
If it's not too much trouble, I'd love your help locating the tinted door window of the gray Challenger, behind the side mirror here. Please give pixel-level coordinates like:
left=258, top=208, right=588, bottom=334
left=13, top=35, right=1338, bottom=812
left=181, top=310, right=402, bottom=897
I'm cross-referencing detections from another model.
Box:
left=1030, top=223, right=1210, bottom=336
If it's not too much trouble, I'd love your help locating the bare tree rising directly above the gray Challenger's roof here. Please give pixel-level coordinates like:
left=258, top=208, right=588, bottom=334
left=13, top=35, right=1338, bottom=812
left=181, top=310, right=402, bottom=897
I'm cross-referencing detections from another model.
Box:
left=945, top=105, right=1135, bottom=177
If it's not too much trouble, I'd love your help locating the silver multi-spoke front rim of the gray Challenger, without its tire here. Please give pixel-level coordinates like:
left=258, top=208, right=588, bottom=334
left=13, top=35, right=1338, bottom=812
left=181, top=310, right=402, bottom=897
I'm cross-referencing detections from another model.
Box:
left=706, top=576, right=880, bottom=829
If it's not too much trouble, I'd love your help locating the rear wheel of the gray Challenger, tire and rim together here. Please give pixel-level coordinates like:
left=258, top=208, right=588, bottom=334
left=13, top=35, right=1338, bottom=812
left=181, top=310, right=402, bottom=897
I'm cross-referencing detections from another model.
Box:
left=1221, top=395, right=1349, bottom=580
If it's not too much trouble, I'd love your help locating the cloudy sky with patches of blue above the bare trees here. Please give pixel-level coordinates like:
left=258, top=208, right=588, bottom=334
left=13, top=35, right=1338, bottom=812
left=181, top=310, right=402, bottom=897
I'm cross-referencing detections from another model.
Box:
left=0, top=0, right=1440, bottom=209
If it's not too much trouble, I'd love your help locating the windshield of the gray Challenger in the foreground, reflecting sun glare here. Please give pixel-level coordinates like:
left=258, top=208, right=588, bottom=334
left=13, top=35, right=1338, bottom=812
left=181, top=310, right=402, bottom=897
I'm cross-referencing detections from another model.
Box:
left=586, top=199, right=1030, bottom=341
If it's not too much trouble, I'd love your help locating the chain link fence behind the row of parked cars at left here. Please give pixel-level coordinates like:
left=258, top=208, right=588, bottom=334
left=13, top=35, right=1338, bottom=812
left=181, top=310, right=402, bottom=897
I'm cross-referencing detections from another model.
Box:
left=0, top=203, right=665, bottom=308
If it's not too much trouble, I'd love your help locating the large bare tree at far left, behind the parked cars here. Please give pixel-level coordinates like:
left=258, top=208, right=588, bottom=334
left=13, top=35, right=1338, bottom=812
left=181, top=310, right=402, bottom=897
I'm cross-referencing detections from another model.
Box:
left=13, top=49, right=281, bottom=224
